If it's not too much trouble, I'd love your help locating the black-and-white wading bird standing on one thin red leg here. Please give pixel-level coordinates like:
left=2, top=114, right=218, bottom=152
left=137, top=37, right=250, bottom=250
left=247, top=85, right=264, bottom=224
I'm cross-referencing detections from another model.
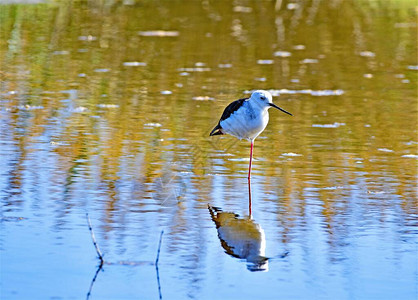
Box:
left=210, top=90, right=293, bottom=181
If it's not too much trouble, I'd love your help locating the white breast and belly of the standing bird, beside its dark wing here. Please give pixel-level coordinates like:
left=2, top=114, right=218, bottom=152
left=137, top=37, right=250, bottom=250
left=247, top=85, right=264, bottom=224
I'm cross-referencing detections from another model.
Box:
left=220, top=97, right=270, bottom=141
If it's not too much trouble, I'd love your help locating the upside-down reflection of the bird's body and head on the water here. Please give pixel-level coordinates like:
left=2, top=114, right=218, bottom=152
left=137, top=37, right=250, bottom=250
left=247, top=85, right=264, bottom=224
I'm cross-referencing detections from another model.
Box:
left=208, top=205, right=268, bottom=272
